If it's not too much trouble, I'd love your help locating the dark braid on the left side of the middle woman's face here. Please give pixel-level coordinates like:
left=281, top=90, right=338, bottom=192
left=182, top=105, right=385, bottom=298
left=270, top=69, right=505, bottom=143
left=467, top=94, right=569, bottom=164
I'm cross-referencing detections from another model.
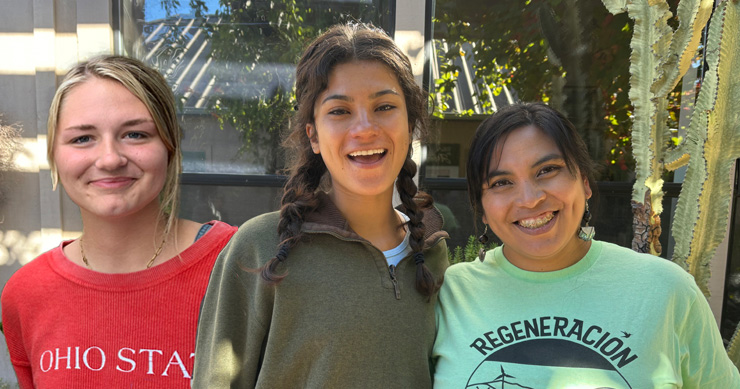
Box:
left=260, top=155, right=326, bottom=285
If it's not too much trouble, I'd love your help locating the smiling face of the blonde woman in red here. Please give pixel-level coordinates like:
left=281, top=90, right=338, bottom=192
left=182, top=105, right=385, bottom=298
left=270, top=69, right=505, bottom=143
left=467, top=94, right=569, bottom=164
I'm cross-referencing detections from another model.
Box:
left=54, top=77, right=168, bottom=218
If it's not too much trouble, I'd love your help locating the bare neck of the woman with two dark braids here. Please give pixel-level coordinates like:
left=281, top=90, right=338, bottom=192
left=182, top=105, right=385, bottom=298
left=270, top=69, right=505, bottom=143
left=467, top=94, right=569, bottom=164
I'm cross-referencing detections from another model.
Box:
left=329, top=187, right=405, bottom=251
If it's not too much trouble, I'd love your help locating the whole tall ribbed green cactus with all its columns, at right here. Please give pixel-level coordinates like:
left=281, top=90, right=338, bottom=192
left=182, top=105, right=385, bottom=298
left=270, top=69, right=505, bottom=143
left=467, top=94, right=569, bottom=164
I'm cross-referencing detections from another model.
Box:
left=603, top=0, right=740, bottom=367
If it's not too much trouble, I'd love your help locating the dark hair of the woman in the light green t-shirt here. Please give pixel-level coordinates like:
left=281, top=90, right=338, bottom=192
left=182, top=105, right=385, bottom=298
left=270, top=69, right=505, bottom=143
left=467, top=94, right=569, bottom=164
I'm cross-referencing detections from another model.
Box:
left=467, top=103, right=598, bottom=216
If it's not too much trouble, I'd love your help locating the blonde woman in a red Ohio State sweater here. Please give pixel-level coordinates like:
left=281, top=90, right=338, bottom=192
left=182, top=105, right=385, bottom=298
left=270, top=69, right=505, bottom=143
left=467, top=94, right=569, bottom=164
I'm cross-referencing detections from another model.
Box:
left=2, top=56, right=236, bottom=389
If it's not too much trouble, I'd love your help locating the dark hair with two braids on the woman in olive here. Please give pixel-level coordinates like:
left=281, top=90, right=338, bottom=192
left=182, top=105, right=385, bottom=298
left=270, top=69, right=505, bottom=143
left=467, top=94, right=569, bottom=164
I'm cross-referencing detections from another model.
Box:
left=261, top=23, right=439, bottom=296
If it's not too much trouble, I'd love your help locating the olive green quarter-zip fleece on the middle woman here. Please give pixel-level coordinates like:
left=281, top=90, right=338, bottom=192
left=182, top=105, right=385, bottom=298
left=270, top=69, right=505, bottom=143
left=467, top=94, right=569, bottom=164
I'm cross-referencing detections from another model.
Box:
left=192, top=195, right=448, bottom=388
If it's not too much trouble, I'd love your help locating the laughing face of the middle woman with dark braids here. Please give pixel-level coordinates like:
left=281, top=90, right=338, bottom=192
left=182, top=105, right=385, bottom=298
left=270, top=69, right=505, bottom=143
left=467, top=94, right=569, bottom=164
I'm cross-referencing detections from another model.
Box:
left=306, top=61, right=411, bottom=197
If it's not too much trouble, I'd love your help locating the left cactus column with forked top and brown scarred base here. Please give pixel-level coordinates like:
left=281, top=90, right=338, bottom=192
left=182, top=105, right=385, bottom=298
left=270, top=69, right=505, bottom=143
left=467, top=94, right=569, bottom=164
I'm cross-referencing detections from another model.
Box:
left=603, top=0, right=713, bottom=255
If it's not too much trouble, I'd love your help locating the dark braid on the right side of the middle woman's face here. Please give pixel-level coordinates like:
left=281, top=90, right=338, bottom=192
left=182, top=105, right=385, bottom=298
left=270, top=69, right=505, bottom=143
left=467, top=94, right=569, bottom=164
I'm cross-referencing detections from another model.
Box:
left=396, top=149, right=440, bottom=297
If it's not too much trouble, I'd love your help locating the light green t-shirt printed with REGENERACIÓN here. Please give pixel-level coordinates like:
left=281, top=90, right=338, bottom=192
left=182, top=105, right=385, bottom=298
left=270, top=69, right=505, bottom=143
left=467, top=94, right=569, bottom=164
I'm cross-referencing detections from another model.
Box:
left=433, top=241, right=740, bottom=389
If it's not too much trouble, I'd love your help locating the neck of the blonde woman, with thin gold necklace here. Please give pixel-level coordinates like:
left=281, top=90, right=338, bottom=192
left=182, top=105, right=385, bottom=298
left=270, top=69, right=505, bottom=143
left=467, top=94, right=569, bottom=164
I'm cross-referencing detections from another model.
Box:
left=77, top=202, right=173, bottom=273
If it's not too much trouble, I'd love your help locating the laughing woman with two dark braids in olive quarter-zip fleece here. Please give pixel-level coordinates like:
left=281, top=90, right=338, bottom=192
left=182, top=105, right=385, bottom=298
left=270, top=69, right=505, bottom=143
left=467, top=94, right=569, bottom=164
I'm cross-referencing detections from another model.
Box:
left=193, top=24, right=448, bottom=388
